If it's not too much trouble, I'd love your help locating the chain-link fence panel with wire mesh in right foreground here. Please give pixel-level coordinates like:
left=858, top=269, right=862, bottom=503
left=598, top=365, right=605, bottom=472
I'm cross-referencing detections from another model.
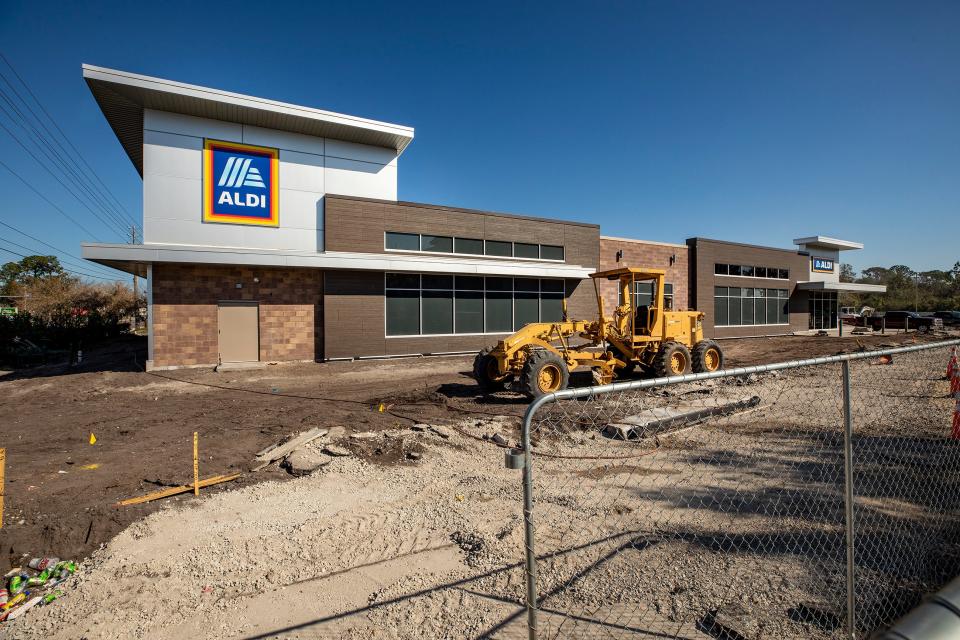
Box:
left=523, top=340, right=960, bottom=640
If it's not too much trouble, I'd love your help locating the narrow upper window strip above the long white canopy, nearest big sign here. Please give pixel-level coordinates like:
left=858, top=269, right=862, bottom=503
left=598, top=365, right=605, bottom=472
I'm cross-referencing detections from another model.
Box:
left=383, top=231, right=564, bottom=262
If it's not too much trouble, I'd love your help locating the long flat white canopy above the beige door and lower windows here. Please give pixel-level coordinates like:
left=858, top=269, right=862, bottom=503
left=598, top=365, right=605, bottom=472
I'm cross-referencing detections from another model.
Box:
left=80, top=243, right=594, bottom=280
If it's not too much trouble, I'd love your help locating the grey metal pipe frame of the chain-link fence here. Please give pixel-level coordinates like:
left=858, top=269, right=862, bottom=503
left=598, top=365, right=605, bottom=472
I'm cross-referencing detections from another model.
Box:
left=517, top=339, right=960, bottom=640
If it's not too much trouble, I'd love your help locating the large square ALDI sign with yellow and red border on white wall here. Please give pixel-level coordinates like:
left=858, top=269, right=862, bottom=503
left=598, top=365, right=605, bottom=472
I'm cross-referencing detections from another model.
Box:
left=203, top=140, right=280, bottom=227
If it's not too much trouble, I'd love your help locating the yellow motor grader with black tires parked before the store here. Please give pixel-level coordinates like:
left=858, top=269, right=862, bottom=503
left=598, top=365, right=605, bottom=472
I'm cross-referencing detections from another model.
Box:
left=473, top=267, right=723, bottom=398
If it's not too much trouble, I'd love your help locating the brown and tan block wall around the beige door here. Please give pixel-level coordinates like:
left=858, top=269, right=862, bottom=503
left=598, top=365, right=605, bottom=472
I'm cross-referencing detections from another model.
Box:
left=152, top=264, right=323, bottom=367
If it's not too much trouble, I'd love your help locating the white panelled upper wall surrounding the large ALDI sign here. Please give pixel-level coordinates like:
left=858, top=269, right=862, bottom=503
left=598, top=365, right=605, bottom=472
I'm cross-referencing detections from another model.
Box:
left=143, top=110, right=397, bottom=252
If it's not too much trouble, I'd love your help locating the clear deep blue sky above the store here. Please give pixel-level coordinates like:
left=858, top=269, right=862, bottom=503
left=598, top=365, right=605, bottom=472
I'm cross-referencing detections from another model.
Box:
left=0, top=0, right=960, bottom=278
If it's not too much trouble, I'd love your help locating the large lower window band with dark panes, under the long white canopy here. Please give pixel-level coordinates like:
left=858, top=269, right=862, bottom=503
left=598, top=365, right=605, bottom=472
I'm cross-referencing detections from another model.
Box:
left=385, top=273, right=564, bottom=336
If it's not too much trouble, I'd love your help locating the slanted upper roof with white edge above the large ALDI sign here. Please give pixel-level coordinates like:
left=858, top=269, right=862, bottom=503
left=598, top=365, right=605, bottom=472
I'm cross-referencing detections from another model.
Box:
left=83, top=64, right=413, bottom=177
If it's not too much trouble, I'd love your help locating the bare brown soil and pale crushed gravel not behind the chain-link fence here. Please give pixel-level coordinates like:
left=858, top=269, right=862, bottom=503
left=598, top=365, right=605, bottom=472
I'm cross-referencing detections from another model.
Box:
left=0, top=328, right=952, bottom=637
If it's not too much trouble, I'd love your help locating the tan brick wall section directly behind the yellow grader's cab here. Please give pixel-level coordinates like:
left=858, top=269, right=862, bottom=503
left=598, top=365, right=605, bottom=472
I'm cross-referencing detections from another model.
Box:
left=599, top=237, right=691, bottom=315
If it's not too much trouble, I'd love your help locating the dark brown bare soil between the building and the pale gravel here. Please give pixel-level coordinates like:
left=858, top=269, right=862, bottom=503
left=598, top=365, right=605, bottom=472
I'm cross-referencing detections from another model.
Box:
left=0, top=335, right=936, bottom=570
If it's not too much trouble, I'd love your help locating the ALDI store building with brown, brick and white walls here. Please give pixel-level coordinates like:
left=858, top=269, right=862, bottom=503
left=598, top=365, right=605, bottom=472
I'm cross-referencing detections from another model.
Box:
left=82, top=65, right=884, bottom=368
